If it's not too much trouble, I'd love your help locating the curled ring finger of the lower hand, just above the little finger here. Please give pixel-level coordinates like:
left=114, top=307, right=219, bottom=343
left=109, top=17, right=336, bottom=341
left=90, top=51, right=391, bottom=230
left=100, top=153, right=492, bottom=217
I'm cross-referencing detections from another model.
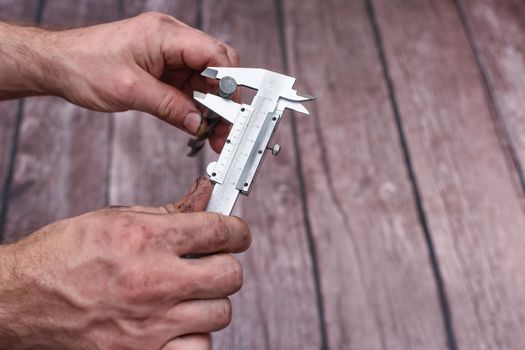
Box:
left=166, top=298, right=232, bottom=335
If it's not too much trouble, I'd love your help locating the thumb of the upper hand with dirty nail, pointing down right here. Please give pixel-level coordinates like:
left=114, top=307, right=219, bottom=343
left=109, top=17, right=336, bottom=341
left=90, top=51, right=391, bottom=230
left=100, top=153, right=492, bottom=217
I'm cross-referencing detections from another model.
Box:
left=132, top=72, right=207, bottom=136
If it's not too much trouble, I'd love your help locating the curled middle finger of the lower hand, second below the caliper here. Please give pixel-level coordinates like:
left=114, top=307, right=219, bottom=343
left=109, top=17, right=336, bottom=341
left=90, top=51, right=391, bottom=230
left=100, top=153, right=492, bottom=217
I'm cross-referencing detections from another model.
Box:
left=177, top=253, right=243, bottom=300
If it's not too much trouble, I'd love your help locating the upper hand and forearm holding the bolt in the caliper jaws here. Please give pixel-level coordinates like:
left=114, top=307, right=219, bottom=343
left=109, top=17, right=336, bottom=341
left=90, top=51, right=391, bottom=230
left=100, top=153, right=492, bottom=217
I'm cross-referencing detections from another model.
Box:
left=0, top=13, right=239, bottom=151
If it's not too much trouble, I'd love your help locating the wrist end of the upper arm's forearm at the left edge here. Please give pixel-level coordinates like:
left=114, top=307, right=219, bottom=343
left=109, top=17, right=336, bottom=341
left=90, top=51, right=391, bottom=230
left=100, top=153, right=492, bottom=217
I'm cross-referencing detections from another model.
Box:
left=0, top=22, right=61, bottom=100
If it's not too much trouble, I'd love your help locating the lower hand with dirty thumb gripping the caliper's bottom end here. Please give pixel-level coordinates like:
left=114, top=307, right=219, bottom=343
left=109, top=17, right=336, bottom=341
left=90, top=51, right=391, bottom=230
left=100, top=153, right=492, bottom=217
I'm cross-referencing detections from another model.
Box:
left=0, top=178, right=250, bottom=350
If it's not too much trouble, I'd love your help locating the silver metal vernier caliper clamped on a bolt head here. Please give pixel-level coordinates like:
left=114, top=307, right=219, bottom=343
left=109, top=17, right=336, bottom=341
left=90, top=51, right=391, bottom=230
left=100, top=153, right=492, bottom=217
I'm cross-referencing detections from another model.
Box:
left=190, top=67, right=313, bottom=215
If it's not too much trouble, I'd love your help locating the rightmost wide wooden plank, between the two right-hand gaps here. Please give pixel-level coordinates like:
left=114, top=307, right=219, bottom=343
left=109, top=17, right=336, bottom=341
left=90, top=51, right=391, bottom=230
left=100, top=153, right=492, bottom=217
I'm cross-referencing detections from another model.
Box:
left=374, top=0, right=525, bottom=349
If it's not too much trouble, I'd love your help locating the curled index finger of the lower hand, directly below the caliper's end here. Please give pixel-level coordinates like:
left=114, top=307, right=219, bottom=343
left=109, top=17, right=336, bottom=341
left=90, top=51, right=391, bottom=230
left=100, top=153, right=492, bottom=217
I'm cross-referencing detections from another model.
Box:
left=165, top=212, right=251, bottom=256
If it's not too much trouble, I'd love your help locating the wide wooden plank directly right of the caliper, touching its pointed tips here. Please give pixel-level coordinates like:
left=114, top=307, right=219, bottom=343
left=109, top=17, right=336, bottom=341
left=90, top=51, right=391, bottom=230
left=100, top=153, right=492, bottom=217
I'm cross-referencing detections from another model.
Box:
left=283, top=0, right=447, bottom=349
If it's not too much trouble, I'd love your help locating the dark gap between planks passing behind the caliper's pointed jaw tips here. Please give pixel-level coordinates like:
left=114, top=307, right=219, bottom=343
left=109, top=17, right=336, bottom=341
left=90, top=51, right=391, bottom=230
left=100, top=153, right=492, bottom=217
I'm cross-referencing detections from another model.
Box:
left=274, top=0, right=329, bottom=350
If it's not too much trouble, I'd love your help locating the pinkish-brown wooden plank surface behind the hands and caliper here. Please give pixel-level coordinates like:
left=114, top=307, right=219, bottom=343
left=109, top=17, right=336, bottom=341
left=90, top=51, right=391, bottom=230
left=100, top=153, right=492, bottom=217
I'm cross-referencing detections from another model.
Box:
left=0, top=0, right=525, bottom=350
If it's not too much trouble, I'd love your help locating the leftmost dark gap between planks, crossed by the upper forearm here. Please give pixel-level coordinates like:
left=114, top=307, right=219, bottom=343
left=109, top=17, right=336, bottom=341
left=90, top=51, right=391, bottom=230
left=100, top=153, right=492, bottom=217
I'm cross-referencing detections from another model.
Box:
left=0, top=0, right=46, bottom=243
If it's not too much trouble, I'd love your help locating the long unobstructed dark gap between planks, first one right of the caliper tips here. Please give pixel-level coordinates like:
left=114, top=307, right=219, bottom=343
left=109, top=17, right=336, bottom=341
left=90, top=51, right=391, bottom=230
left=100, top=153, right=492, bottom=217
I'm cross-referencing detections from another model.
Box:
left=364, top=0, right=457, bottom=350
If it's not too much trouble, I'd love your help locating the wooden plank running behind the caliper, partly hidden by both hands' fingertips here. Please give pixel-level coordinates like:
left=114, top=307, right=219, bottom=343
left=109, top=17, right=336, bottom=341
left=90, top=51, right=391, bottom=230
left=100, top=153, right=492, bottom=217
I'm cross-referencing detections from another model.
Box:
left=202, top=0, right=320, bottom=349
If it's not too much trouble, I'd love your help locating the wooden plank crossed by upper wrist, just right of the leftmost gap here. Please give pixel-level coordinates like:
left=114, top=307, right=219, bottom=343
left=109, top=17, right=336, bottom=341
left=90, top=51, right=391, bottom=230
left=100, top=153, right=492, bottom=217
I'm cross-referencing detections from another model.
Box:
left=5, top=0, right=117, bottom=241
